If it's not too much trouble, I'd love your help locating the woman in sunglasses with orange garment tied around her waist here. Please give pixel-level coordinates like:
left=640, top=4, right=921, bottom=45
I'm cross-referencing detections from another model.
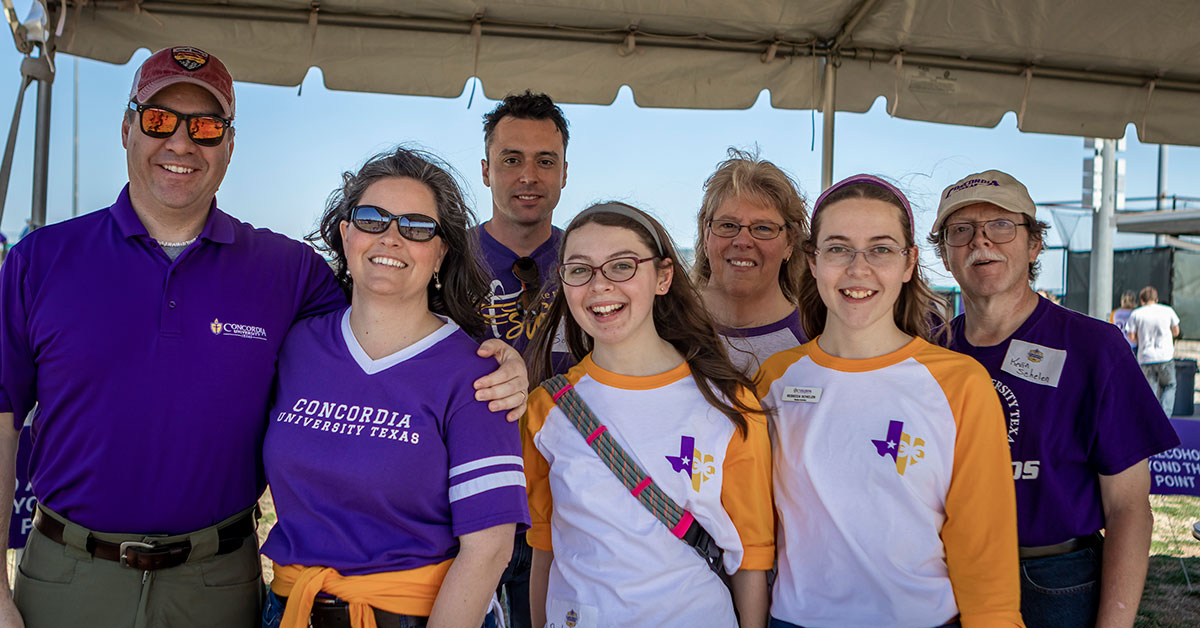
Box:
left=263, top=148, right=529, bottom=628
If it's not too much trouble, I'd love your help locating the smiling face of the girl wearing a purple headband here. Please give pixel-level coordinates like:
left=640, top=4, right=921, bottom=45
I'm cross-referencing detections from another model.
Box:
left=809, top=198, right=916, bottom=337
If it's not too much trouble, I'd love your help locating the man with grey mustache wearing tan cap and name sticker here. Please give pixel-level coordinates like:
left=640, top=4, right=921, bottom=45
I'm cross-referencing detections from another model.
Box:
left=929, top=171, right=1180, bottom=628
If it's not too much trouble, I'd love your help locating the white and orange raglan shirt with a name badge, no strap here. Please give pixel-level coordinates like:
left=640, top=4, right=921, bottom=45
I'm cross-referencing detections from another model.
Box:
left=757, top=339, right=1022, bottom=628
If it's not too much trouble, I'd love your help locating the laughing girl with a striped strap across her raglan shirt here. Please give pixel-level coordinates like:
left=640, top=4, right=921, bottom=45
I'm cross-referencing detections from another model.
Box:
left=522, top=203, right=775, bottom=628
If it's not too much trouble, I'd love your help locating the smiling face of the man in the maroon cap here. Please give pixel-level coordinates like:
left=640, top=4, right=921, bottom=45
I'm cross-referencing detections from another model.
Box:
left=121, top=83, right=233, bottom=219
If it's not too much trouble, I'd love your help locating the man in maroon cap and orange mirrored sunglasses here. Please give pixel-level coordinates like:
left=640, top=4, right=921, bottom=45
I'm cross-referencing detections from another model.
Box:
left=0, top=46, right=527, bottom=628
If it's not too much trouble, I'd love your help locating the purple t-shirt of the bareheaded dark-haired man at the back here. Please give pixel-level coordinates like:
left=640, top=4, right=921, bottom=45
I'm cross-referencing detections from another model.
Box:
left=474, top=226, right=571, bottom=373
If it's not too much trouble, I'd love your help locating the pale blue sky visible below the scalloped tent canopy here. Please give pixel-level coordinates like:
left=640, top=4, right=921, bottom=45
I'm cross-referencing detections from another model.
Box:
left=0, top=25, right=1200, bottom=289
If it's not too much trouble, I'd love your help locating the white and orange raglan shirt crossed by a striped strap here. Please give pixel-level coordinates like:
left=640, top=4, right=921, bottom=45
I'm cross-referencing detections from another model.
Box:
left=522, top=355, right=775, bottom=628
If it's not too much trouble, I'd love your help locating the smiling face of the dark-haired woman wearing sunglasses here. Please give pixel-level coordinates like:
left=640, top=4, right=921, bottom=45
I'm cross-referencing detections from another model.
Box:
left=340, top=178, right=446, bottom=307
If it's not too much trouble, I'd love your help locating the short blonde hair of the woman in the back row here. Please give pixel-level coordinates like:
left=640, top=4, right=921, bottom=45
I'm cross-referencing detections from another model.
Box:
left=691, top=148, right=809, bottom=303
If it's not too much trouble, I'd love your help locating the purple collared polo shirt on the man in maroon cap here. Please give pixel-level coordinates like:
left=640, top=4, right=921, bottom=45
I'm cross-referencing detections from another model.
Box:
left=0, top=186, right=346, bottom=534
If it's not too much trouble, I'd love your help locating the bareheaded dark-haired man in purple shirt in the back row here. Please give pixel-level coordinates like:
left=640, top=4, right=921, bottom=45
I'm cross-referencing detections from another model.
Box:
left=476, top=90, right=569, bottom=628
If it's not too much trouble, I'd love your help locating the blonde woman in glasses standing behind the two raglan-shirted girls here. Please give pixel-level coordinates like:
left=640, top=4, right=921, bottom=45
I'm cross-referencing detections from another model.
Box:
left=692, top=149, right=809, bottom=375
